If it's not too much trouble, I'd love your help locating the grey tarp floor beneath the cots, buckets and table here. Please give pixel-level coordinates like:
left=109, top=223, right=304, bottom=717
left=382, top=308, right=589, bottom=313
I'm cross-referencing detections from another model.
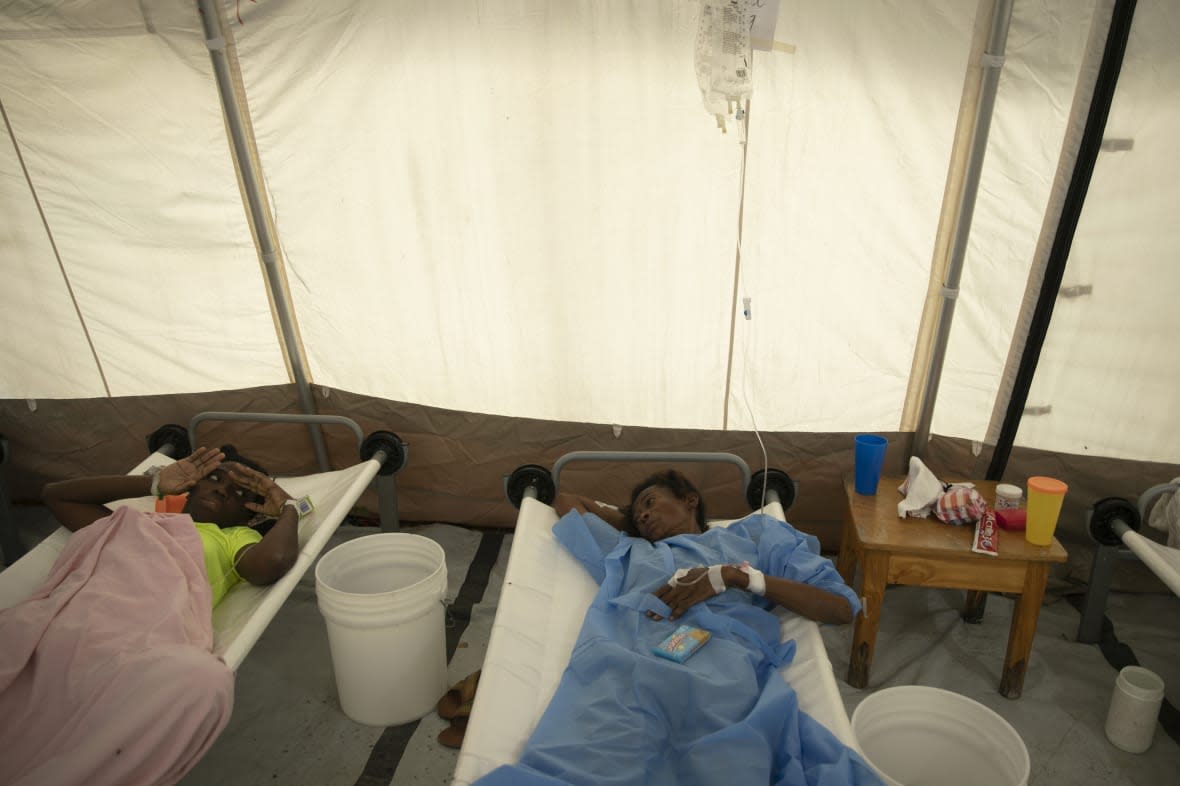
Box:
left=2, top=507, right=1180, bottom=786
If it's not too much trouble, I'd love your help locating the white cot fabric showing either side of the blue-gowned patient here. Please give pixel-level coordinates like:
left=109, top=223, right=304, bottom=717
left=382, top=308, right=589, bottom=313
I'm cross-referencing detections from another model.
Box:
left=452, top=499, right=856, bottom=786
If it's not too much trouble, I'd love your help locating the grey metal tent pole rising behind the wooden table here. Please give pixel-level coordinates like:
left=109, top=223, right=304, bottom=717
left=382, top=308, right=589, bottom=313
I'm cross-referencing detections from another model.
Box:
left=913, top=0, right=1012, bottom=457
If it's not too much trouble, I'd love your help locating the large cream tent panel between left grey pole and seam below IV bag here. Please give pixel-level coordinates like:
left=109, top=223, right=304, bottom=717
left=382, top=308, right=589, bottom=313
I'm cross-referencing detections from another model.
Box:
left=235, top=0, right=740, bottom=427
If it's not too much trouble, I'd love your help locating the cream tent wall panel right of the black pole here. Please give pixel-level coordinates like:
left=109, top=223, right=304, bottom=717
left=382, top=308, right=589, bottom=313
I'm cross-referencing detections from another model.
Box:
left=1016, top=0, right=1180, bottom=462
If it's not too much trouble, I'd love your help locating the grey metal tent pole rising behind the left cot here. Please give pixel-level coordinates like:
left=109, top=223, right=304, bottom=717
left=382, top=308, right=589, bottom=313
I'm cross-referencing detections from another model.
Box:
left=199, top=0, right=332, bottom=472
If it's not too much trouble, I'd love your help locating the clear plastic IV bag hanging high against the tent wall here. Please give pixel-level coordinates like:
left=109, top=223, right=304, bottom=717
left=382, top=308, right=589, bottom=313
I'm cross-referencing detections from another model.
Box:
left=694, top=0, right=753, bottom=131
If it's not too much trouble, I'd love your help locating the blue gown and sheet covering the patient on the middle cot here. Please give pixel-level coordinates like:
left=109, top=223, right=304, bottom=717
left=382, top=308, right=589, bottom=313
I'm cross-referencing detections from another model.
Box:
left=477, top=511, right=881, bottom=786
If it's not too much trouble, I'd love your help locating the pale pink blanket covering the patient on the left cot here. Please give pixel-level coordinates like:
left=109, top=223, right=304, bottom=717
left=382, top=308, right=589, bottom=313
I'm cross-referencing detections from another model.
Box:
left=0, top=507, right=234, bottom=786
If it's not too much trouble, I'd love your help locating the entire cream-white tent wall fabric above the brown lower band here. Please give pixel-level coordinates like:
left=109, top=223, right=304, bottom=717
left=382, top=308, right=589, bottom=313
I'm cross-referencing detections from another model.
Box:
left=0, top=0, right=1180, bottom=461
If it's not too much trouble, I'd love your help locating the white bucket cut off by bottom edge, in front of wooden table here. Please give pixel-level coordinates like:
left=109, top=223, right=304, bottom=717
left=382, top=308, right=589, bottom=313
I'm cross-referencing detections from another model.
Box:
left=852, top=686, right=1029, bottom=786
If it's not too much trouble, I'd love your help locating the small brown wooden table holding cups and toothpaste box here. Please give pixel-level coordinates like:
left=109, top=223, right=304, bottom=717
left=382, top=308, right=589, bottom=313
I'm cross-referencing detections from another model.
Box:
left=837, top=477, right=1068, bottom=699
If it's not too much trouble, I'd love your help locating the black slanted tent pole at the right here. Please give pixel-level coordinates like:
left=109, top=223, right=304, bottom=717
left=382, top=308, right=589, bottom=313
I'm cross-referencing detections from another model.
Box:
left=986, top=0, right=1136, bottom=480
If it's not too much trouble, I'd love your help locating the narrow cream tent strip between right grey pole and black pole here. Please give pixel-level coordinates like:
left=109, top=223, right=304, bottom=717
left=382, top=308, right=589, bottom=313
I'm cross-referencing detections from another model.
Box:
left=931, top=0, right=1094, bottom=441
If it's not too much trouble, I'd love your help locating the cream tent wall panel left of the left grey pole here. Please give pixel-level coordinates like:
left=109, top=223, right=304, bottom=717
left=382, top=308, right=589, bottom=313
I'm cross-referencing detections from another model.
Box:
left=0, top=17, right=288, bottom=398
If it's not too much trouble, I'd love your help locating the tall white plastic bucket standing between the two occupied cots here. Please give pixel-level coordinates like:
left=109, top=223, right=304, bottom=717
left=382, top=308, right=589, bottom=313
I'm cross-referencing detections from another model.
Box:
left=315, top=532, right=447, bottom=726
